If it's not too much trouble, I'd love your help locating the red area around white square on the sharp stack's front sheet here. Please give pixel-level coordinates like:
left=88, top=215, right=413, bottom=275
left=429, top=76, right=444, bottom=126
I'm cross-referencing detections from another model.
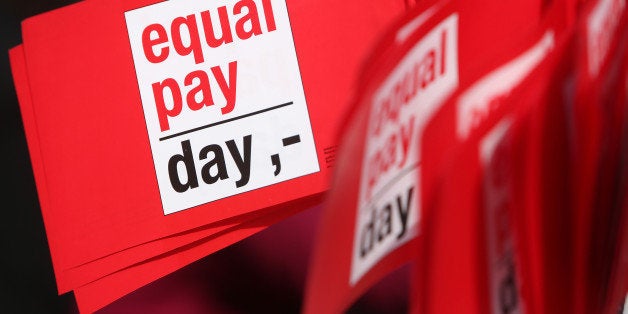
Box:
left=14, top=0, right=410, bottom=291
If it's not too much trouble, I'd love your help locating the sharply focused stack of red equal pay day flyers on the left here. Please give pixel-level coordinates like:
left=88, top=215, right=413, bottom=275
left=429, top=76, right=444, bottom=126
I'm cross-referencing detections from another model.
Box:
left=10, top=0, right=406, bottom=312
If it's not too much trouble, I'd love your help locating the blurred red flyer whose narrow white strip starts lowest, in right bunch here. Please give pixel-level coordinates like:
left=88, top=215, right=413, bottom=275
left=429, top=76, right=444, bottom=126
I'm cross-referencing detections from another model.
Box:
left=424, top=114, right=525, bottom=313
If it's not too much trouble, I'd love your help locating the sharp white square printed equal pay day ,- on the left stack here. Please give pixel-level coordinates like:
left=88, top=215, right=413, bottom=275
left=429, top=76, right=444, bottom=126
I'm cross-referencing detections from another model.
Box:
left=125, top=0, right=319, bottom=214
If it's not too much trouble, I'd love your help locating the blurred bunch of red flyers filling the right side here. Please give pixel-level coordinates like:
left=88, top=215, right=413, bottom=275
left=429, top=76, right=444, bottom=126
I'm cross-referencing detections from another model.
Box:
left=304, top=0, right=628, bottom=314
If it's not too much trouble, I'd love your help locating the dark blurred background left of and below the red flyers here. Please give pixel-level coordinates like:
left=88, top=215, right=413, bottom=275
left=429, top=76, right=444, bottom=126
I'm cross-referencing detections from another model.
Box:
left=0, top=0, right=408, bottom=313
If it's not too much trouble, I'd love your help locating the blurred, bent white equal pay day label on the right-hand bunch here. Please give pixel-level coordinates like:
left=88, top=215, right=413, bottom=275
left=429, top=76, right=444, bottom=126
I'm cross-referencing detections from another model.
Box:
left=349, top=14, right=458, bottom=285
